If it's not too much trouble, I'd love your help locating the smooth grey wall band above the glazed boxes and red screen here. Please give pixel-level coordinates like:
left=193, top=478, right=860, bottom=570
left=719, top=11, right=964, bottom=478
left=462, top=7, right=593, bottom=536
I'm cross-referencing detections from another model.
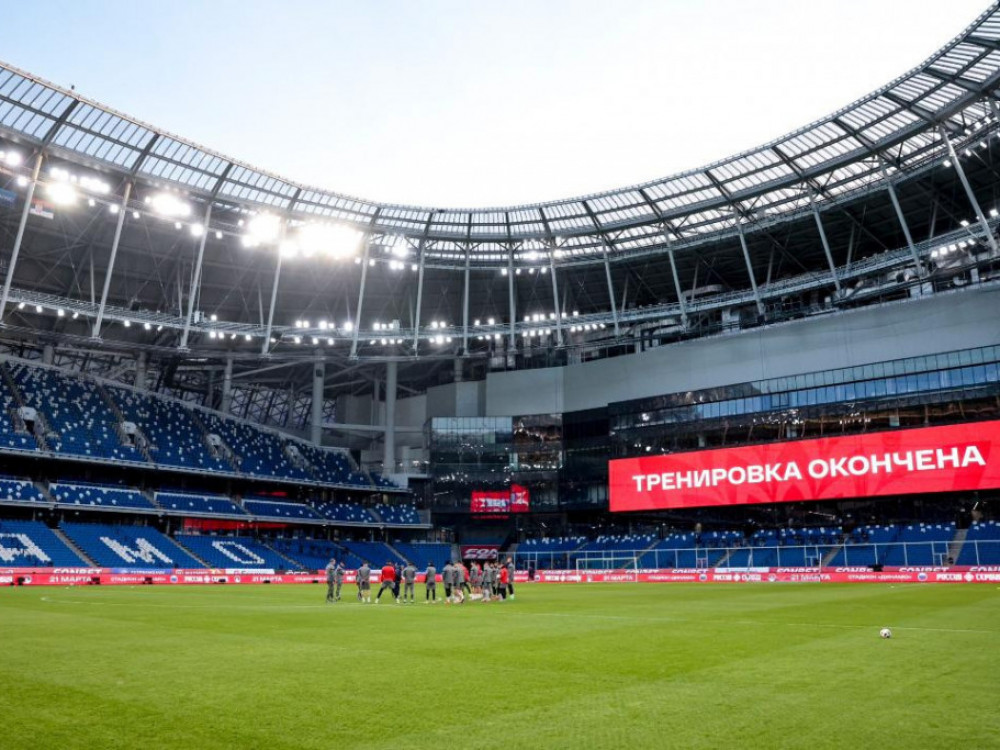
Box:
left=486, top=287, right=1000, bottom=416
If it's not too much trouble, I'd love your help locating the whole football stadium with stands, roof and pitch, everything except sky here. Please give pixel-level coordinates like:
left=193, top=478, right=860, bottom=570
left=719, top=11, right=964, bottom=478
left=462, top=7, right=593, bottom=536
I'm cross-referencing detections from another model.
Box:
left=0, top=3, right=1000, bottom=750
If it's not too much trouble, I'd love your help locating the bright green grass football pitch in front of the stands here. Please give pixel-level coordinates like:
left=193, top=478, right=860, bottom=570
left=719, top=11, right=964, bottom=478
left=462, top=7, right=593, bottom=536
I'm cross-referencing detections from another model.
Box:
left=0, top=584, right=1000, bottom=750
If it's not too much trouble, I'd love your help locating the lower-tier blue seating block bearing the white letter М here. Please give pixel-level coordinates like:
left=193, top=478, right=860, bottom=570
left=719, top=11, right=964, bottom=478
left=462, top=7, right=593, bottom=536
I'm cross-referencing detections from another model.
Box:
left=60, top=523, right=202, bottom=568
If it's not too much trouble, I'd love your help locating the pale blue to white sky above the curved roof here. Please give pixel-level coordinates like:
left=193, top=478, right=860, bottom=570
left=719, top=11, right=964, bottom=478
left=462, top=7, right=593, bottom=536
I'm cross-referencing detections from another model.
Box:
left=0, top=0, right=987, bottom=208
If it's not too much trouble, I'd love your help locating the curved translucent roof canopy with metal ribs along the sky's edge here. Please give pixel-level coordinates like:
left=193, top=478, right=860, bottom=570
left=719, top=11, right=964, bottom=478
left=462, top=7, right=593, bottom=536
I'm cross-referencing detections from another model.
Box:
left=0, top=3, right=1000, bottom=274
